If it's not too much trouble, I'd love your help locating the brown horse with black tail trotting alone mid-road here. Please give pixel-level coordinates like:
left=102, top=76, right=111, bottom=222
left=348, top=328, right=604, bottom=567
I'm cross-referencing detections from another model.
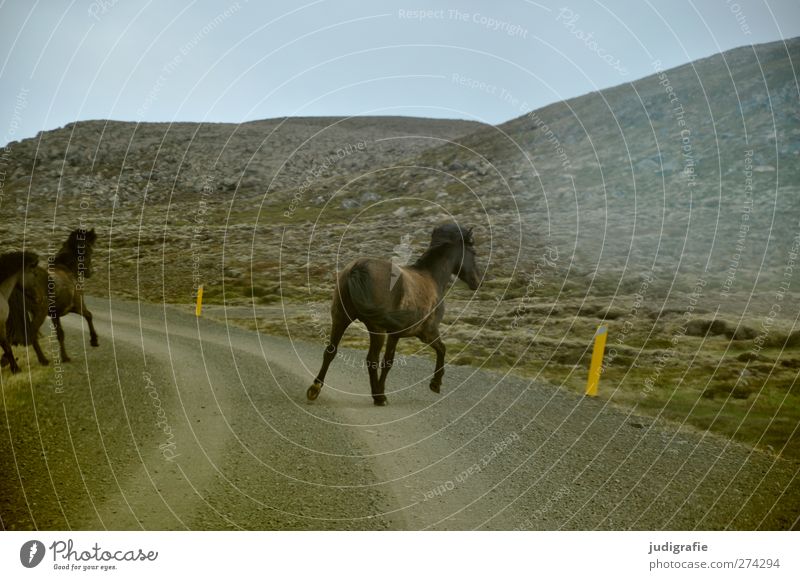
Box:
left=306, top=224, right=480, bottom=405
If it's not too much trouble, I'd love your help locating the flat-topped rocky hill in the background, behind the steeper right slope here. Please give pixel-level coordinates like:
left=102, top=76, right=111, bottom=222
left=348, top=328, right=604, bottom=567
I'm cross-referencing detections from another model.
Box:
left=3, top=117, right=481, bottom=208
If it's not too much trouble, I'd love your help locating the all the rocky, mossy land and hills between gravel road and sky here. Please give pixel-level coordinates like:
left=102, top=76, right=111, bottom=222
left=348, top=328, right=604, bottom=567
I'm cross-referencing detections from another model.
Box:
left=0, top=39, right=800, bottom=459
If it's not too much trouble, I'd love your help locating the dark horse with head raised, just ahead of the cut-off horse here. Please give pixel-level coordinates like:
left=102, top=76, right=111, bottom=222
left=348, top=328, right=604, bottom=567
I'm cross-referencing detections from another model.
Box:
left=8, top=229, right=99, bottom=365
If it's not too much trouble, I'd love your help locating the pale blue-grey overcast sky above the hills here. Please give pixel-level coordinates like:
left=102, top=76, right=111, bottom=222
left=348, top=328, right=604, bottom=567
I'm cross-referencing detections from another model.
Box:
left=0, top=0, right=800, bottom=145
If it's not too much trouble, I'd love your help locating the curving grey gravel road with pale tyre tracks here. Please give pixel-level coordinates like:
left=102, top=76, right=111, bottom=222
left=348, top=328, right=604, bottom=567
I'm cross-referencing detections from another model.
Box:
left=0, top=299, right=800, bottom=530
